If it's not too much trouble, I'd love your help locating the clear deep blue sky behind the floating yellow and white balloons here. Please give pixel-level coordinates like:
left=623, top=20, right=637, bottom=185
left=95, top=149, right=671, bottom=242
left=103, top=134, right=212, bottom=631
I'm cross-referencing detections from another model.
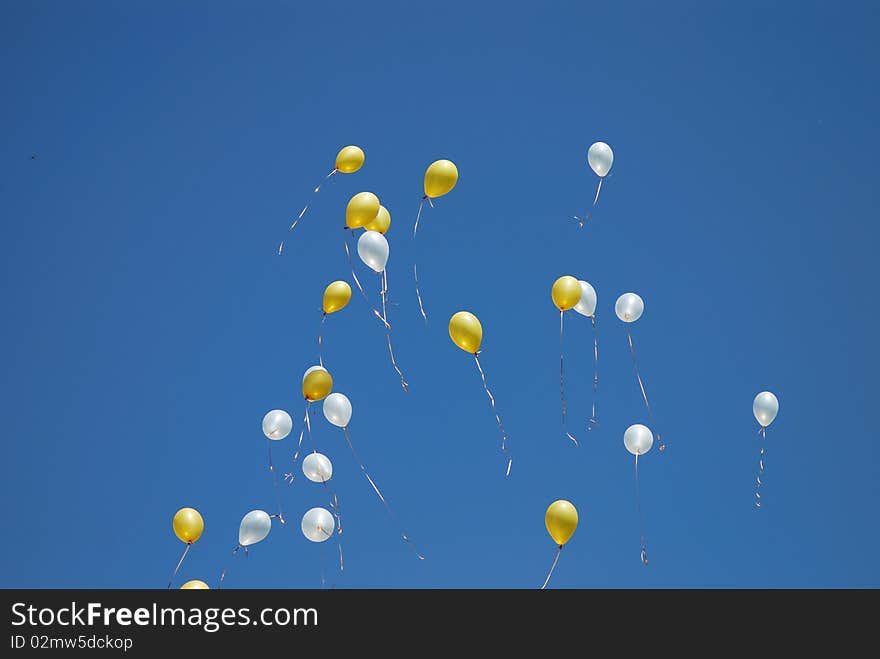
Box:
left=0, top=1, right=880, bottom=588
